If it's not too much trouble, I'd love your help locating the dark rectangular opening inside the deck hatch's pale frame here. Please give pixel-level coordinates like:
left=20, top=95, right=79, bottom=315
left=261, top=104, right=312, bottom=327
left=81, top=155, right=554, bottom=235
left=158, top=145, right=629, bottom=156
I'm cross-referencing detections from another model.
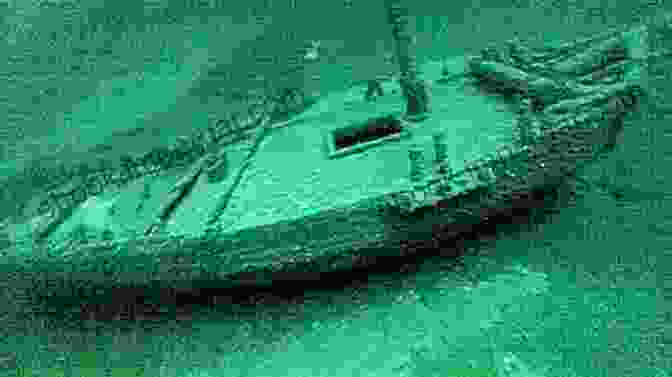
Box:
left=333, top=116, right=402, bottom=151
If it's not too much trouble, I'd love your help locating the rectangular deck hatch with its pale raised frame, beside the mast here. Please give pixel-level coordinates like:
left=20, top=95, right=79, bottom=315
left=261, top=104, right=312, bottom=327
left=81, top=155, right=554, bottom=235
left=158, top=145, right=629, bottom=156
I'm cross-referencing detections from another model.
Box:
left=328, top=115, right=403, bottom=158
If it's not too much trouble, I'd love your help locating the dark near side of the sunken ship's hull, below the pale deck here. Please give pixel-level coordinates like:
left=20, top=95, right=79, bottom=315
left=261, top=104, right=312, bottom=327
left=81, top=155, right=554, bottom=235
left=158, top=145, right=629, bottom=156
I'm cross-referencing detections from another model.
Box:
left=3, top=103, right=622, bottom=290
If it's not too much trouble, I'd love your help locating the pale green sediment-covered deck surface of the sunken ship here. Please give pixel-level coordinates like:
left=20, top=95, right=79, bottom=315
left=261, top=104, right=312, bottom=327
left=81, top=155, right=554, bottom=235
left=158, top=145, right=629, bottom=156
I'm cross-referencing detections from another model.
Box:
left=14, top=56, right=515, bottom=241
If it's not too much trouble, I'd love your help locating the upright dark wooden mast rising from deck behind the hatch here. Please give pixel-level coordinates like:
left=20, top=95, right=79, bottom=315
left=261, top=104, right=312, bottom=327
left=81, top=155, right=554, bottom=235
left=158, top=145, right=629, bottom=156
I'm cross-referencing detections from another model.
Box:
left=385, top=0, right=430, bottom=121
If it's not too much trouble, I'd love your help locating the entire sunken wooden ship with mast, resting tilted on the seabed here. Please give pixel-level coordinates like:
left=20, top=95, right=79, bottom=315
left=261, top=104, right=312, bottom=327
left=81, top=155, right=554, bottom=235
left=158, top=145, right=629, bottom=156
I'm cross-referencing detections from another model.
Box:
left=1, top=6, right=650, bottom=288
